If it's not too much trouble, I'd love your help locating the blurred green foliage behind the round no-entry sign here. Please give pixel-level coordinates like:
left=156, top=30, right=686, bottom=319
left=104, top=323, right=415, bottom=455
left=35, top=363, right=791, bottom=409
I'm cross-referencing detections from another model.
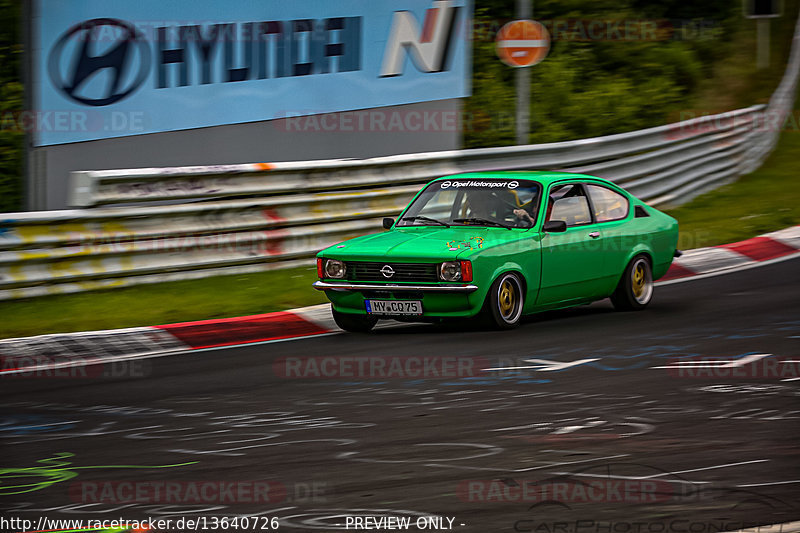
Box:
left=464, top=0, right=797, bottom=148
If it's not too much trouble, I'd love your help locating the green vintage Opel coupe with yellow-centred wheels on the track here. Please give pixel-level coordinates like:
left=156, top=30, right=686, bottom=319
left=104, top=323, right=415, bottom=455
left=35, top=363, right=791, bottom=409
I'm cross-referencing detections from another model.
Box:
left=314, top=172, right=680, bottom=332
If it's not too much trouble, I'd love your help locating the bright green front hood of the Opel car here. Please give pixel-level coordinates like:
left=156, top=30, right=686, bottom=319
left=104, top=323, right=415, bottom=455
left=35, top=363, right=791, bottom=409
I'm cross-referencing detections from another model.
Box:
left=323, top=226, right=531, bottom=261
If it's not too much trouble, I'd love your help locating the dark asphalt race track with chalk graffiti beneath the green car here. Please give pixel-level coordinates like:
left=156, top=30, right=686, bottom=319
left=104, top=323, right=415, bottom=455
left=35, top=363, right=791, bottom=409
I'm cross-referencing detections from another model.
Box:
left=0, top=258, right=800, bottom=533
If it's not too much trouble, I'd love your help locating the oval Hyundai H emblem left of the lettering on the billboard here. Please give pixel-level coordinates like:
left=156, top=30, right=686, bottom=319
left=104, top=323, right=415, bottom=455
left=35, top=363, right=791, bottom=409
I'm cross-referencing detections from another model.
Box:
left=47, top=18, right=150, bottom=106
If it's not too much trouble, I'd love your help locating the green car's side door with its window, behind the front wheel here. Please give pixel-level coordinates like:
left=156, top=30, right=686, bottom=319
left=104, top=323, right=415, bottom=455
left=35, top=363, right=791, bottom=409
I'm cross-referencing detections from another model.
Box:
left=537, top=181, right=604, bottom=305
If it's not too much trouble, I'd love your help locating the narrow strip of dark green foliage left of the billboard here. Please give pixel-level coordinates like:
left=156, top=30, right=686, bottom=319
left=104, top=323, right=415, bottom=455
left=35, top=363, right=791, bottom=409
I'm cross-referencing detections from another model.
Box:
left=0, top=0, right=25, bottom=212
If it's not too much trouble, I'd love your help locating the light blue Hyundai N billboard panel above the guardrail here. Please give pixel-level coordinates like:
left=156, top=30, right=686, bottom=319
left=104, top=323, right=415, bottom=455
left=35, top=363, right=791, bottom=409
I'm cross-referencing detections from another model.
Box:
left=37, top=0, right=471, bottom=145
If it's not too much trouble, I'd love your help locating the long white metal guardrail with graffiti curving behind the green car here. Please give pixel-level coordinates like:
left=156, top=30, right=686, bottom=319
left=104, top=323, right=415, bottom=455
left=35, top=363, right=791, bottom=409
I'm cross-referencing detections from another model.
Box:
left=0, top=13, right=800, bottom=300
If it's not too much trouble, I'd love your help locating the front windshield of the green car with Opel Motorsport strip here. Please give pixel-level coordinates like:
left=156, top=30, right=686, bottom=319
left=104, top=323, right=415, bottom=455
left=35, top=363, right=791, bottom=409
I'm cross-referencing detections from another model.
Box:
left=397, top=179, right=541, bottom=229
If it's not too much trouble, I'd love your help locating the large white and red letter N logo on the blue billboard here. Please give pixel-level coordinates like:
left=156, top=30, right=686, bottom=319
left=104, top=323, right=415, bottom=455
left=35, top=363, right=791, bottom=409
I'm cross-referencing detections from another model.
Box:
left=381, top=0, right=461, bottom=77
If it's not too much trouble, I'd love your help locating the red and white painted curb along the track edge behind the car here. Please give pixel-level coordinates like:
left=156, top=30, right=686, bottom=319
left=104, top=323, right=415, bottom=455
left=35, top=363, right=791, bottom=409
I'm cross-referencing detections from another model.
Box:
left=0, top=226, right=800, bottom=377
